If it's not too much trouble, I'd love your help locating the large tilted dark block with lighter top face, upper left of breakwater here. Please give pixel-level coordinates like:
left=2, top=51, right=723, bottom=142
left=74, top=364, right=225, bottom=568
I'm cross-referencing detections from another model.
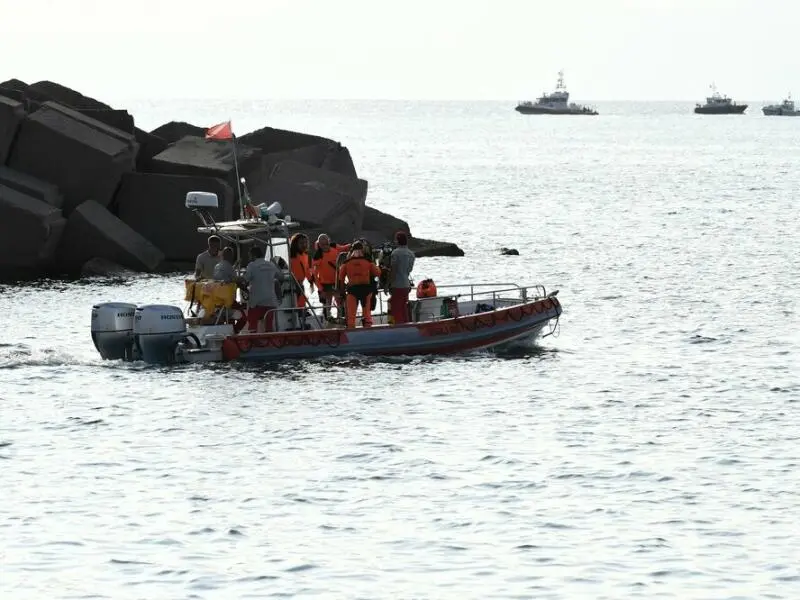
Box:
left=8, top=103, right=137, bottom=214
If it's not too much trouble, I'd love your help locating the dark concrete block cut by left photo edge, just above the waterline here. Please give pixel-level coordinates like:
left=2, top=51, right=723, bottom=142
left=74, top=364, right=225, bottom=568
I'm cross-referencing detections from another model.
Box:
left=0, top=185, right=66, bottom=276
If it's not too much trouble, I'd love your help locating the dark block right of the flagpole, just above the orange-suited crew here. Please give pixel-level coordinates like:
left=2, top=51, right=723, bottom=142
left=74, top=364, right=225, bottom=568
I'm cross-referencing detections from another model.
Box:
left=251, top=161, right=367, bottom=240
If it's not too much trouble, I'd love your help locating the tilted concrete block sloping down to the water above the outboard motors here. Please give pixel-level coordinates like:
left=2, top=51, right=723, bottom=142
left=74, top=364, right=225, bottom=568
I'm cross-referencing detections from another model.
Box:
left=58, top=200, right=164, bottom=274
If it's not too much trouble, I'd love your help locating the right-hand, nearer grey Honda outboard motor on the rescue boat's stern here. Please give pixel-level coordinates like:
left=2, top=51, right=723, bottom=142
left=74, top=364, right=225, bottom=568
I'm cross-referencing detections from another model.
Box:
left=133, top=304, right=191, bottom=364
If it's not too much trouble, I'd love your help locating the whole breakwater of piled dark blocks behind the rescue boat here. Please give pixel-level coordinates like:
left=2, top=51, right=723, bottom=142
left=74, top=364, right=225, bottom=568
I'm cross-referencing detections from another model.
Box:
left=0, top=80, right=463, bottom=280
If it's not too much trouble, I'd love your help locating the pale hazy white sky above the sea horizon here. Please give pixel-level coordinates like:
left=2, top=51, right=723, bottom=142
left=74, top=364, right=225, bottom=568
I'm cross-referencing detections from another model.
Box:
left=0, top=0, right=800, bottom=102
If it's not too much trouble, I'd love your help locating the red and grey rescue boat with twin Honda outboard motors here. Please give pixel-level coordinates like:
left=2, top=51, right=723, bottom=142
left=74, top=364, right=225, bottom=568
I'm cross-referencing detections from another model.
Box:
left=91, top=188, right=562, bottom=365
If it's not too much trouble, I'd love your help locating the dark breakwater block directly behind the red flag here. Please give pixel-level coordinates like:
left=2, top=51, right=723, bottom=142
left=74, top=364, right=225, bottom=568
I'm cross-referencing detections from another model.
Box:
left=150, top=136, right=264, bottom=189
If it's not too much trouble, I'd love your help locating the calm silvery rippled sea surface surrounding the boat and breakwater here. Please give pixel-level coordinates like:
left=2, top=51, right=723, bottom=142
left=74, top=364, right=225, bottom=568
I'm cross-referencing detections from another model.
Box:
left=0, top=101, right=800, bottom=599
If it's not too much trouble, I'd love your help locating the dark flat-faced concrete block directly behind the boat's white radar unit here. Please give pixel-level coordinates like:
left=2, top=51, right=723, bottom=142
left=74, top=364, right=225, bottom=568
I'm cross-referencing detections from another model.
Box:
left=115, top=173, right=234, bottom=261
